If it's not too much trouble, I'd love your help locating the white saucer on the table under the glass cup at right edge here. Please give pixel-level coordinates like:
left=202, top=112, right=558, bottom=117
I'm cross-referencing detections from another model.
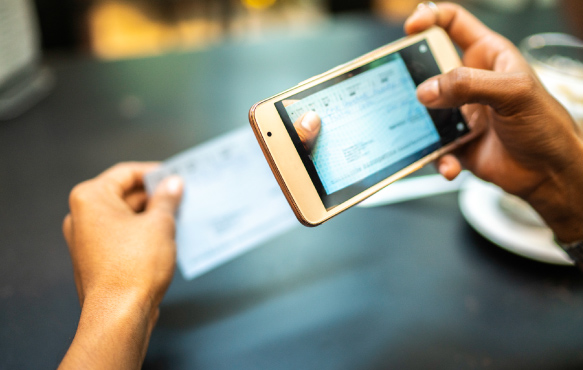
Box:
left=459, top=176, right=573, bottom=265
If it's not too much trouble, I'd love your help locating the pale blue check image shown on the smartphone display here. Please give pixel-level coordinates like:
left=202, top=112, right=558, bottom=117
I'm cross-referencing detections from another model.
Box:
left=285, top=54, right=440, bottom=194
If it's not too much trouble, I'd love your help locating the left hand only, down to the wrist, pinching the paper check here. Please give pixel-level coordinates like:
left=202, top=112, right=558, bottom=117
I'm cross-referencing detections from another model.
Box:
left=63, top=163, right=183, bottom=308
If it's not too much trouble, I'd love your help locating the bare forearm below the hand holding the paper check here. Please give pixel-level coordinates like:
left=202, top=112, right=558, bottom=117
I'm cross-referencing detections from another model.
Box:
left=59, top=294, right=158, bottom=369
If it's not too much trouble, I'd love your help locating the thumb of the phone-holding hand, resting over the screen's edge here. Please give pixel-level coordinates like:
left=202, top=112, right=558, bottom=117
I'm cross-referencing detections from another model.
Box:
left=417, top=67, right=537, bottom=116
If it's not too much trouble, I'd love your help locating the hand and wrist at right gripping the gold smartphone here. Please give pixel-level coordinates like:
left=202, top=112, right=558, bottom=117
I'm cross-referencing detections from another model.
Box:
left=405, top=3, right=583, bottom=241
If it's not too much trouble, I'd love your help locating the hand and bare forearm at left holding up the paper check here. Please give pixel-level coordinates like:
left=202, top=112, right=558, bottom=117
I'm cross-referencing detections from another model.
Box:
left=59, top=163, right=183, bottom=369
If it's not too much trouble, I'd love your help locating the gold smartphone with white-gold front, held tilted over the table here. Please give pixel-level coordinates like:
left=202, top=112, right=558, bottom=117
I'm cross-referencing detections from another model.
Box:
left=249, top=27, right=473, bottom=226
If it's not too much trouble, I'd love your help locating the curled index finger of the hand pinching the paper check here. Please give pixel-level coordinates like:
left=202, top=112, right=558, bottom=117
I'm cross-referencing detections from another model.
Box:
left=95, top=162, right=159, bottom=197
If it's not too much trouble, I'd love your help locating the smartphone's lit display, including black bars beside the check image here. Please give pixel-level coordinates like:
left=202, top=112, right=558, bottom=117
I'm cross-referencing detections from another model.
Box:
left=275, top=40, right=469, bottom=209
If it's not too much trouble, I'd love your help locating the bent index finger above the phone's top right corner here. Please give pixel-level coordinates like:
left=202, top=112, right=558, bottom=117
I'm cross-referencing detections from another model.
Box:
left=404, top=3, right=497, bottom=51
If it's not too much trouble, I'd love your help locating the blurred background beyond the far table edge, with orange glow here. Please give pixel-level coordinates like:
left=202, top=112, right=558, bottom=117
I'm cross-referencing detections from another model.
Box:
left=0, top=0, right=583, bottom=121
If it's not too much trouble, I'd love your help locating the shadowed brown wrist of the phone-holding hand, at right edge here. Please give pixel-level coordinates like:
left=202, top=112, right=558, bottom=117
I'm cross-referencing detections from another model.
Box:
left=525, top=142, right=583, bottom=243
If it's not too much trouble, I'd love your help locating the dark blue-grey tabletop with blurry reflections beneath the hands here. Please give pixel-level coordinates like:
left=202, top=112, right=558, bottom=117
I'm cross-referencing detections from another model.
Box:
left=0, top=5, right=583, bottom=369
